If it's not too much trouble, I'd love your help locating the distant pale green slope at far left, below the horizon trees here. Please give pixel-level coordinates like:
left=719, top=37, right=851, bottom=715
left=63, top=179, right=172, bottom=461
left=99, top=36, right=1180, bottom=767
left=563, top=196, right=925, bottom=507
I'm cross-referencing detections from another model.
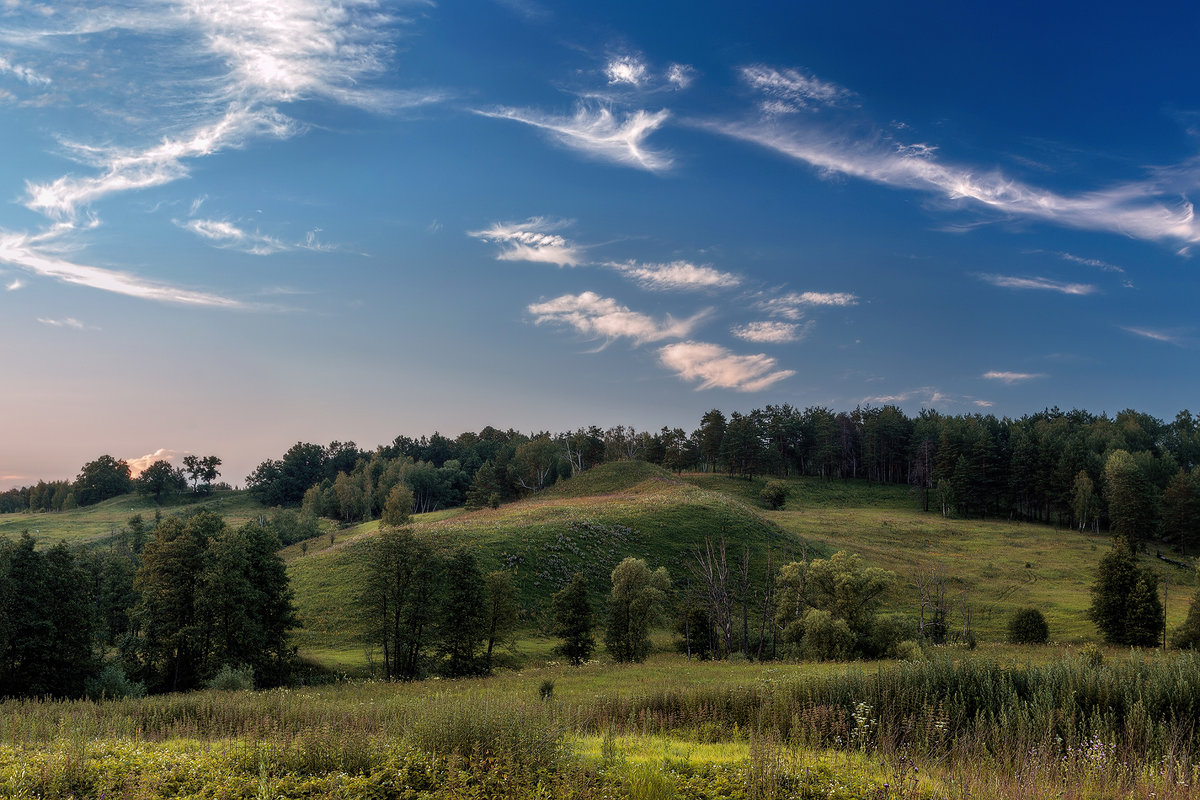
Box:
left=0, top=489, right=266, bottom=545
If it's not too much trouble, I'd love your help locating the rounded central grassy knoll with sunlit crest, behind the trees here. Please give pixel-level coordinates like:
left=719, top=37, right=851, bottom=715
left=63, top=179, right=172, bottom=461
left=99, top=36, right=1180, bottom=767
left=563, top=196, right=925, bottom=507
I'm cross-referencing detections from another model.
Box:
left=286, top=462, right=800, bottom=667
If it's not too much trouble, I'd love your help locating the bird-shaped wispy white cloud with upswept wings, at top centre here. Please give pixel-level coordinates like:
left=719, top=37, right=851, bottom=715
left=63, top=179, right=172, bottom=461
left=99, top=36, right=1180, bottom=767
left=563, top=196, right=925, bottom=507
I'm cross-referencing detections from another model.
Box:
left=476, top=106, right=671, bottom=173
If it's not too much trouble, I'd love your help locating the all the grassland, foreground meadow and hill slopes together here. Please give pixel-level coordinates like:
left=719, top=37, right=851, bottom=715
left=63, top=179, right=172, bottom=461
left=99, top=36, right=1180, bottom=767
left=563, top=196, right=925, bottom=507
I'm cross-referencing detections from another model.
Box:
left=0, top=464, right=1200, bottom=800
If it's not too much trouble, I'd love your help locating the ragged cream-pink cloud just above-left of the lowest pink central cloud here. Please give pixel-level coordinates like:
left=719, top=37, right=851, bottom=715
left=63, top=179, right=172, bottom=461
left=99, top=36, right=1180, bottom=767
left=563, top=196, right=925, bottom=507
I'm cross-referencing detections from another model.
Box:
left=528, top=291, right=707, bottom=344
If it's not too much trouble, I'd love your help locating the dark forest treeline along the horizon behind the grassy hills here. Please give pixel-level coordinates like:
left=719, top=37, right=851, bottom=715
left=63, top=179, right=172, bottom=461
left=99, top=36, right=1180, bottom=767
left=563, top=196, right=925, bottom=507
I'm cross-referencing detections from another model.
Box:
left=0, top=404, right=1200, bottom=541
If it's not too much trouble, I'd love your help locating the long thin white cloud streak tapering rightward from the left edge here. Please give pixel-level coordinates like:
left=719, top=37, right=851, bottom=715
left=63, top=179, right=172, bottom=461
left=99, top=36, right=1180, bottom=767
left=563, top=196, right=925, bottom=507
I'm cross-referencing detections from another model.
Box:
left=0, top=234, right=247, bottom=308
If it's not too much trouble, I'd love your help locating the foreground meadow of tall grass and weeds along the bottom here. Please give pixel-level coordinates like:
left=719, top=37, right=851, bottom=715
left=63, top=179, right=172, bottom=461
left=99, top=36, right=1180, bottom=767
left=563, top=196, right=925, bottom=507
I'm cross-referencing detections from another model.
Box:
left=0, top=648, right=1200, bottom=800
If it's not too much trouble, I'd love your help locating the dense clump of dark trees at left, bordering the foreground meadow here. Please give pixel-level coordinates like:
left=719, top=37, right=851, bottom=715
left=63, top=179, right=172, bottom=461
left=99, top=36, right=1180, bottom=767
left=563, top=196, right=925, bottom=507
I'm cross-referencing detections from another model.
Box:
left=0, top=511, right=298, bottom=697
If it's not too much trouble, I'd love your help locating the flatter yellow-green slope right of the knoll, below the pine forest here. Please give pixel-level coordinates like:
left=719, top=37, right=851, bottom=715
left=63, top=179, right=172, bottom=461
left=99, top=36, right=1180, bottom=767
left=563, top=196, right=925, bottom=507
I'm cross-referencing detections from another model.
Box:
left=686, top=474, right=1195, bottom=642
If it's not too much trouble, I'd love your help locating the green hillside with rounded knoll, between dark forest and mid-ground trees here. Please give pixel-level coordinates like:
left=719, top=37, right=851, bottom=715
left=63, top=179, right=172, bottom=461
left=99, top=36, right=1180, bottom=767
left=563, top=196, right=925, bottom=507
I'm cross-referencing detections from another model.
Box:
left=286, top=462, right=1195, bottom=668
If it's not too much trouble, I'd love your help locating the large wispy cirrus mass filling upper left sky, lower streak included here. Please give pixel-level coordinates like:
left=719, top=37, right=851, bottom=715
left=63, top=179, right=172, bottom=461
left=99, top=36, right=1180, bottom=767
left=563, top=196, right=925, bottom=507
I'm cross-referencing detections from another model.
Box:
left=0, top=0, right=443, bottom=307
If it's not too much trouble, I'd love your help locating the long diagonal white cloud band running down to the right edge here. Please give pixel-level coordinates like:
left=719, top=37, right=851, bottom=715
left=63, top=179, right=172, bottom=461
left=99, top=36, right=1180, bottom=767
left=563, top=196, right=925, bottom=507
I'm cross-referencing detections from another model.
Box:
left=708, top=121, right=1200, bottom=243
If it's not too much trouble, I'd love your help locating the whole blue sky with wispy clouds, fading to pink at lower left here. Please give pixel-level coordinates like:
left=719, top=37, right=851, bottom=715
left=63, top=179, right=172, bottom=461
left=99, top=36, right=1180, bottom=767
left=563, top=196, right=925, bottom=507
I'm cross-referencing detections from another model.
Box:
left=0, top=0, right=1200, bottom=487
